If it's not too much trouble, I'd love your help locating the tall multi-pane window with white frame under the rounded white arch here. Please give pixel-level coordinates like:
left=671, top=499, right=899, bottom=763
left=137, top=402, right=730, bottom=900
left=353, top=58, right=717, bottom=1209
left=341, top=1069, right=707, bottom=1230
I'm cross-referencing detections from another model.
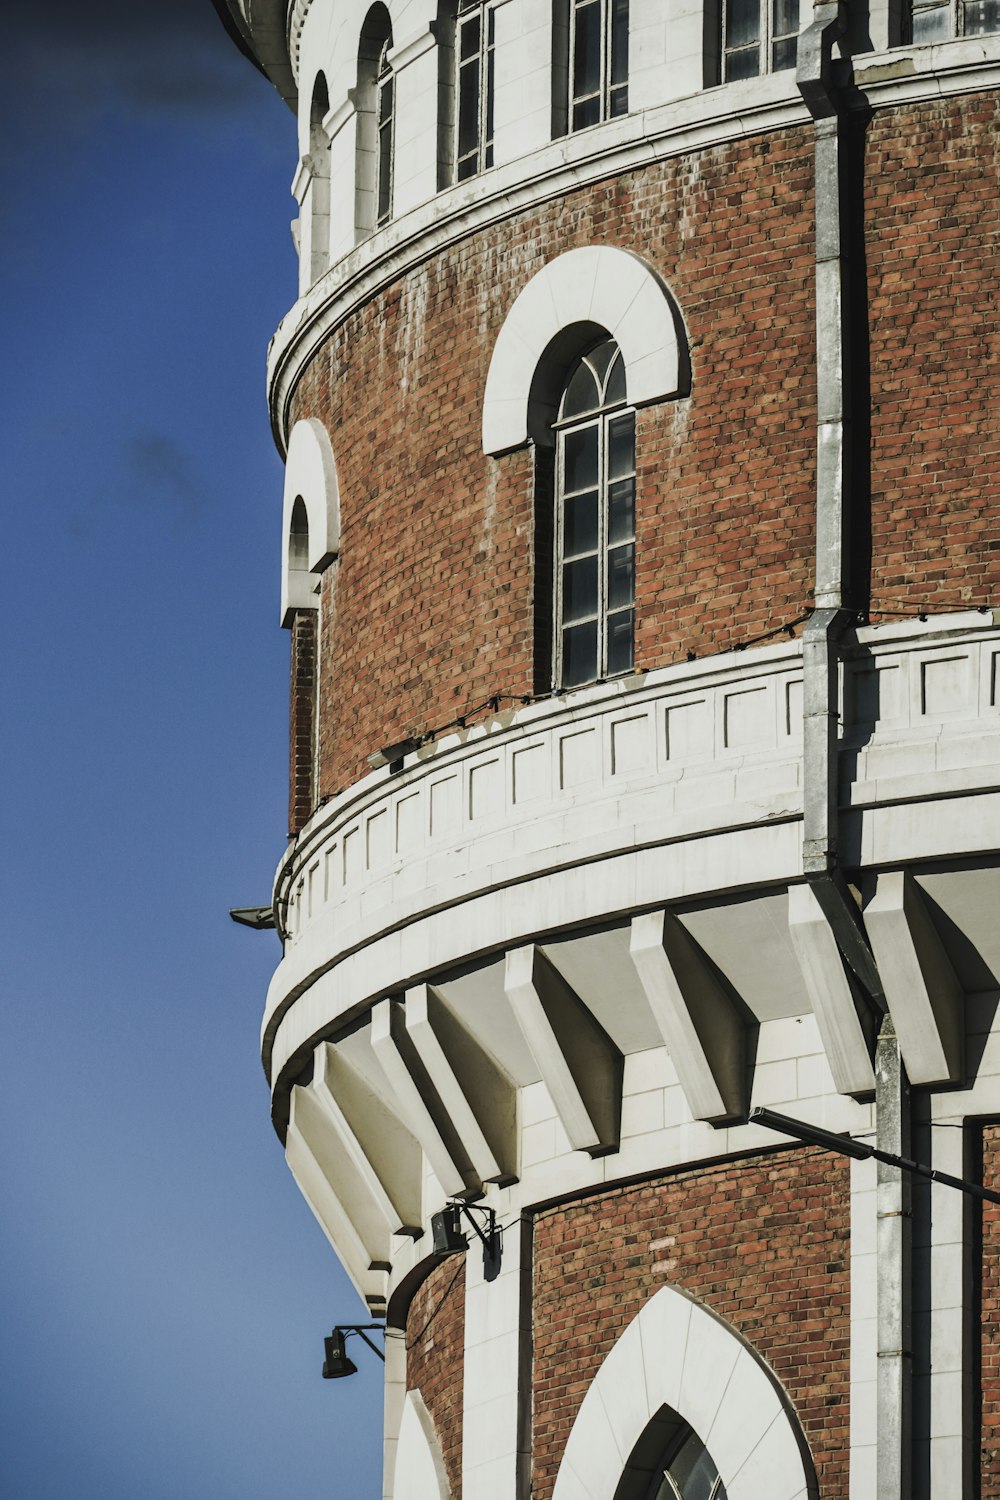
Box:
left=553, top=339, right=636, bottom=687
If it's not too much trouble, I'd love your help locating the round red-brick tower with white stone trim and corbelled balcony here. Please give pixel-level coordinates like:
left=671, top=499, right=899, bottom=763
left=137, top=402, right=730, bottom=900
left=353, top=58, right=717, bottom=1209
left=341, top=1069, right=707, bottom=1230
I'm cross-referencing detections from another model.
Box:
left=217, top=0, right=1000, bottom=1500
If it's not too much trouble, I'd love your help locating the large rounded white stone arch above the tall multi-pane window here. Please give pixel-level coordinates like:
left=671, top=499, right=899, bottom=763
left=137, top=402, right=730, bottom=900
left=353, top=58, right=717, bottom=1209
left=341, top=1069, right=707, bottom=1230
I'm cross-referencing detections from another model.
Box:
left=483, top=245, right=688, bottom=453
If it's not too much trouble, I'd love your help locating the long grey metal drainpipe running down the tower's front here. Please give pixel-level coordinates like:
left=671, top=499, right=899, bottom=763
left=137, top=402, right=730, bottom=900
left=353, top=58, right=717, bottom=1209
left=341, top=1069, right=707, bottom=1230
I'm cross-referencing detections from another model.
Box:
left=796, top=17, right=912, bottom=1500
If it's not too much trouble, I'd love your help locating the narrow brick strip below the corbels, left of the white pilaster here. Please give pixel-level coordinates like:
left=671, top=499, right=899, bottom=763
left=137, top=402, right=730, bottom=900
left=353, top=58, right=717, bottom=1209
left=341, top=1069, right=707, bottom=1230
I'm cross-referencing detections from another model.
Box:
left=406, top=1256, right=465, bottom=1500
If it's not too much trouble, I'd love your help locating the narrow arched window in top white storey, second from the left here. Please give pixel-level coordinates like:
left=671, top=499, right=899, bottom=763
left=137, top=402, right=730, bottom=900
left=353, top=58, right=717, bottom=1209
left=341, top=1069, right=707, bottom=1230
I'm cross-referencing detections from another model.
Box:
left=355, top=3, right=396, bottom=240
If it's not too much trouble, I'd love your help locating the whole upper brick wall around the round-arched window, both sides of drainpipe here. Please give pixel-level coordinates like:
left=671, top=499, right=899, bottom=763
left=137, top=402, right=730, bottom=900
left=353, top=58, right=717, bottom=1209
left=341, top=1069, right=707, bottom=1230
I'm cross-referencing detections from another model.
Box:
left=292, top=95, right=1000, bottom=795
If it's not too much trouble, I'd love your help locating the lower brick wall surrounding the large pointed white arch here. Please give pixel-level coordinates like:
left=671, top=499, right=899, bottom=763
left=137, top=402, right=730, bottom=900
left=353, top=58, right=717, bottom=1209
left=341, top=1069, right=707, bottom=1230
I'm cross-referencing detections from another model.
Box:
left=532, top=1151, right=850, bottom=1500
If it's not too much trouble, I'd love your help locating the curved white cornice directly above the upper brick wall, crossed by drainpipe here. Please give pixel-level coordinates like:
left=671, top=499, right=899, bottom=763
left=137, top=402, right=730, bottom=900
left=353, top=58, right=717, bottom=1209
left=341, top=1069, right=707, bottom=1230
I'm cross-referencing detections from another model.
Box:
left=263, top=36, right=1000, bottom=455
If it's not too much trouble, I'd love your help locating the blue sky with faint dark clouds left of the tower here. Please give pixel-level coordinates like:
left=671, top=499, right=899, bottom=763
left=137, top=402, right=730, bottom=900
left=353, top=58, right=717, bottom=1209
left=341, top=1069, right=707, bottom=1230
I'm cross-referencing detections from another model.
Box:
left=0, top=0, right=382, bottom=1500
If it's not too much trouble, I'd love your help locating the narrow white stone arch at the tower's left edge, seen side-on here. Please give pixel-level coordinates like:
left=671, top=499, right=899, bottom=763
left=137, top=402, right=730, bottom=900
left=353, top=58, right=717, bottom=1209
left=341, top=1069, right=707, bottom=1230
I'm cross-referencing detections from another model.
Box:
left=282, top=417, right=340, bottom=626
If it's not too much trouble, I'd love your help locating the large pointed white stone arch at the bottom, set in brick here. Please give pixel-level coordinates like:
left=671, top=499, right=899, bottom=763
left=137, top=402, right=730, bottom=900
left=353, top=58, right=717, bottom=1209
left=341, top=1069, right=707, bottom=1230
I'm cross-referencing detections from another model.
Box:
left=553, top=1287, right=819, bottom=1500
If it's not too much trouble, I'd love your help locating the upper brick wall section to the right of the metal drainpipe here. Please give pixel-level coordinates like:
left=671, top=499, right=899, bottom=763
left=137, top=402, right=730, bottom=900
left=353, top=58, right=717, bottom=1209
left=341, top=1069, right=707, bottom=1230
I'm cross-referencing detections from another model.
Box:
left=865, top=93, right=1000, bottom=611
